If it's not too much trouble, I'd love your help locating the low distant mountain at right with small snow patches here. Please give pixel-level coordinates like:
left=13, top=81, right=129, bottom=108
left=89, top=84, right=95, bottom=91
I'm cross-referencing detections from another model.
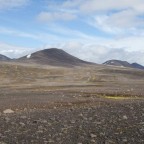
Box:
left=103, top=60, right=144, bottom=69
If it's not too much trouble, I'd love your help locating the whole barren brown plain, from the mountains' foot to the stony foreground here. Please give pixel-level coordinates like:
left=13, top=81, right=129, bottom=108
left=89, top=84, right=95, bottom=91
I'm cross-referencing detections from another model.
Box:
left=0, top=62, right=144, bottom=144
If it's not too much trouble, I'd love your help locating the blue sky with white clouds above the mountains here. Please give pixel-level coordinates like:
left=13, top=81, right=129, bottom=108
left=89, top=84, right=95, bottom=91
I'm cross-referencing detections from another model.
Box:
left=0, top=0, right=144, bottom=65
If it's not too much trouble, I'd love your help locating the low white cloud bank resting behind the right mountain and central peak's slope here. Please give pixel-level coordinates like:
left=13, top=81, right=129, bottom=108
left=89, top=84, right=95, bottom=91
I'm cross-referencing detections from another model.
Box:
left=57, top=41, right=144, bottom=65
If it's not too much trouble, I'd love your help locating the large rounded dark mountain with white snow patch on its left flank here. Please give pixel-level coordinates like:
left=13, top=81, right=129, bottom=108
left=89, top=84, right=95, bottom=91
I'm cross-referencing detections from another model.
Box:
left=18, top=48, right=93, bottom=66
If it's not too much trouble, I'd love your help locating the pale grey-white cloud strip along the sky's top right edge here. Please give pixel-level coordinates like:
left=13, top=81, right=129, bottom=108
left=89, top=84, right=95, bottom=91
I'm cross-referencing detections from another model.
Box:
left=79, top=0, right=144, bottom=12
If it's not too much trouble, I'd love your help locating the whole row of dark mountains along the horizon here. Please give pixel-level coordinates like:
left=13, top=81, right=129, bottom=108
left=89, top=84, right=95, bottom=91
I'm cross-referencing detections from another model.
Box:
left=0, top=48, right=144, bottom=69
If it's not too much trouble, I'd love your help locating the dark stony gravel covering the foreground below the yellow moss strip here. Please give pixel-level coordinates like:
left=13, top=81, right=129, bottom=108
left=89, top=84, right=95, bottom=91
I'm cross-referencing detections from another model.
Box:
left=0, top=91, right=144, bottom=144
